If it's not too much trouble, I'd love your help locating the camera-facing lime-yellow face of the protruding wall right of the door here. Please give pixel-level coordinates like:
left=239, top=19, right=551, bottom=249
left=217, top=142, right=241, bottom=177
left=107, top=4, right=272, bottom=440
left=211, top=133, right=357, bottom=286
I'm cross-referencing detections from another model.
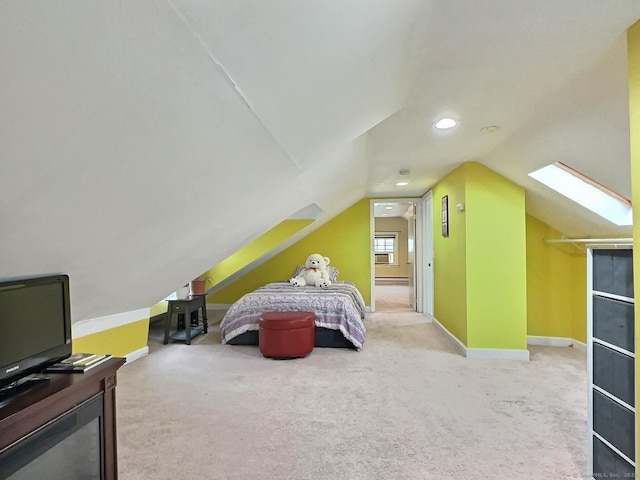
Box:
left=464, top=162, right=527, bottom=349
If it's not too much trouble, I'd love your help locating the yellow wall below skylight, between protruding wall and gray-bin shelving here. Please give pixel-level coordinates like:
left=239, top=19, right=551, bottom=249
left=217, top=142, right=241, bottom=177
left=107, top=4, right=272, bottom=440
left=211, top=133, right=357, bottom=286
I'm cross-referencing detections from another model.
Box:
left=526, top=215, right=587, bottom=343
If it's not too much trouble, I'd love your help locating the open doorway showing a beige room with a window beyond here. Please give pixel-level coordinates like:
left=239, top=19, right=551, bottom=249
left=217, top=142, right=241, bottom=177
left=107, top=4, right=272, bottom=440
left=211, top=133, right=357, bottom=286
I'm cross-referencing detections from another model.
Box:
left=371, top=199, right=418, bottom=312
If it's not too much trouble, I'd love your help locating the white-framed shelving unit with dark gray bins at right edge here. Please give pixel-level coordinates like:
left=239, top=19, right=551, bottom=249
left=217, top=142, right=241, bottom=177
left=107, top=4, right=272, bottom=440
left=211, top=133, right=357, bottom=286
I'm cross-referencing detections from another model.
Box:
left=587, top=246, right=637, bottom=479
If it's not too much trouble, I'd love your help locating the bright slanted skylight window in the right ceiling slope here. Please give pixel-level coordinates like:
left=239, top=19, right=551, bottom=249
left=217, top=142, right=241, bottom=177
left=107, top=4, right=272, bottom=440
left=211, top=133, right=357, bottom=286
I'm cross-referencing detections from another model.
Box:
left=529, top=162, right=633, bottom=226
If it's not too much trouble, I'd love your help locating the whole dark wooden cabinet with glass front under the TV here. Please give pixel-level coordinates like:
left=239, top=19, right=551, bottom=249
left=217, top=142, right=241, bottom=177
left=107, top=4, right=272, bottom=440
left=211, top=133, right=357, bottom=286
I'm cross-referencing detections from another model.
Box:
left=0, top=358, right=124, bottom=480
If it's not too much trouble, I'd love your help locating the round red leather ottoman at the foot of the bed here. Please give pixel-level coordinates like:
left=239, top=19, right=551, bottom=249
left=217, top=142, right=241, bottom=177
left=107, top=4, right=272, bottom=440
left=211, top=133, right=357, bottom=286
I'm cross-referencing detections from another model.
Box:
left=258, top=312, right=316, bottom=358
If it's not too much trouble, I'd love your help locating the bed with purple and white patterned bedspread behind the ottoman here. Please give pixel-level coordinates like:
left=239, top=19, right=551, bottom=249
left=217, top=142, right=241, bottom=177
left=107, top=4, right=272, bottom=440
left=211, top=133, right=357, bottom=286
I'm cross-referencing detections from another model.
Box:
left=220, top=281, right=366, bottom=350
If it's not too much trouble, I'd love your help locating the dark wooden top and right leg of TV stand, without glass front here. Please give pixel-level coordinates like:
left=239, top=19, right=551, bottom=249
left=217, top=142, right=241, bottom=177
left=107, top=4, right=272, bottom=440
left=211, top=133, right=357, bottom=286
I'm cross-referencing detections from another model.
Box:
left=0, top=358, right=125, bottom=480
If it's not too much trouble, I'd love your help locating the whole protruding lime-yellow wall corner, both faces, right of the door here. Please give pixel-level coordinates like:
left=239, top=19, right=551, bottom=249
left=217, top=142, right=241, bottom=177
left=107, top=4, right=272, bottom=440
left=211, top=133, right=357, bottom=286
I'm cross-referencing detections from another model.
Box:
left=433, top=162, right=527, bottom=350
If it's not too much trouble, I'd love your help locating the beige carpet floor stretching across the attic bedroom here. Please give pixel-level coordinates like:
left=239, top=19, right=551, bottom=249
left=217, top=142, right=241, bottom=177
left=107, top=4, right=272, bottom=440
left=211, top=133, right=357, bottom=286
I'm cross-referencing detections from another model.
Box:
left=117, top=312, right=587, bottom=480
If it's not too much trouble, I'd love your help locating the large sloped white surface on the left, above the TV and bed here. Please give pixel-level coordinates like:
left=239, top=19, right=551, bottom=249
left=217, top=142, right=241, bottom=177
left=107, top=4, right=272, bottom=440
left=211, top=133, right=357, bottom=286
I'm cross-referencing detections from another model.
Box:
left=0, top=0, right=416, bottom=321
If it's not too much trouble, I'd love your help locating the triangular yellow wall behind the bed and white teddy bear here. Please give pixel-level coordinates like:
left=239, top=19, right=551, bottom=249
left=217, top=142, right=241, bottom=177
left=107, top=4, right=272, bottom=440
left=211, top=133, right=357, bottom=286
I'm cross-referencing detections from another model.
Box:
left=207, top=199, right=371, bottom=305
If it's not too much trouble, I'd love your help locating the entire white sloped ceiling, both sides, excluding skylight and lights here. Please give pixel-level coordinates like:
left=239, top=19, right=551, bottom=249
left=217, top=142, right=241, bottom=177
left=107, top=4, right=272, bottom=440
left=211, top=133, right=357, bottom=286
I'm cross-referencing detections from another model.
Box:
left=0, top=0, right=640, bottom=320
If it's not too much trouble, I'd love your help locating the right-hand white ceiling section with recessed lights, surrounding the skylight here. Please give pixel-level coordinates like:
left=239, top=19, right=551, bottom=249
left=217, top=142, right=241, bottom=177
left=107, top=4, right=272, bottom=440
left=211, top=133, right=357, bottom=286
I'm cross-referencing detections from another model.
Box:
left=368, top=0, right=640, bottom=237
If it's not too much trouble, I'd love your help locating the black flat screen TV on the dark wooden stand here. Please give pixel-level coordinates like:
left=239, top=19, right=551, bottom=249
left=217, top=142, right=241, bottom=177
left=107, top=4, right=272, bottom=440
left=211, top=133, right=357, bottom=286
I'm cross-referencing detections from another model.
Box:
left=0, top=275, right=71, bottom=388
